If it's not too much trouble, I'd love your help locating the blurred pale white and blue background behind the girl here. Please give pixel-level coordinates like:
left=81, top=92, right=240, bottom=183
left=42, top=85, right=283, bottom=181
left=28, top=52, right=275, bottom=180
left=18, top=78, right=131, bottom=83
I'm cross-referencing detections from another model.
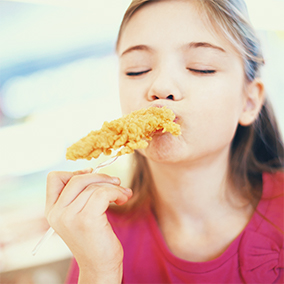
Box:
left=0, top=0, right=284, bottom=284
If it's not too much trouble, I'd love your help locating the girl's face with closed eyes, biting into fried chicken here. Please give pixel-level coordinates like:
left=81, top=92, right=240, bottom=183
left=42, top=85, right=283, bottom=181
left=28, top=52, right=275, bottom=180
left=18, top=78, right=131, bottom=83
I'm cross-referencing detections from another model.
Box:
left=118, top=1, right=244, bottom=162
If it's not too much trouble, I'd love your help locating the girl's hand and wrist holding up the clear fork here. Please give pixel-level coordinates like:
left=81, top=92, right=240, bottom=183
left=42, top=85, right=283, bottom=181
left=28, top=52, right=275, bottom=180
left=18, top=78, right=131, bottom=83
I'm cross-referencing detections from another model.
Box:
left=45, top=169, right=132, bottom=283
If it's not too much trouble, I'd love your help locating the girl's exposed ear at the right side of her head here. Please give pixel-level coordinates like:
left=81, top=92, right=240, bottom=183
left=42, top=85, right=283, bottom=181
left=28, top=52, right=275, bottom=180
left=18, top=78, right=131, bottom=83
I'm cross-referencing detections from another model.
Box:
left=239, top=78, right=264, bottom=126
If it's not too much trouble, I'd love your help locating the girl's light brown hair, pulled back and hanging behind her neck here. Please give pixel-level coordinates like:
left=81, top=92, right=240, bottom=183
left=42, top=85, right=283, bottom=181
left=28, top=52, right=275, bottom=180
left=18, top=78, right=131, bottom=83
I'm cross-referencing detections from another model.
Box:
left=114, top=0, right=284, bottom=211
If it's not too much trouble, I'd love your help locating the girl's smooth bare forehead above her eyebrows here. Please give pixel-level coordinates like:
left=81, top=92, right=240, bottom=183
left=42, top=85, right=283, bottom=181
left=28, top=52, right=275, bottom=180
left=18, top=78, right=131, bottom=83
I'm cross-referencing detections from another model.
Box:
left=118, top=0, right=231, bottom=53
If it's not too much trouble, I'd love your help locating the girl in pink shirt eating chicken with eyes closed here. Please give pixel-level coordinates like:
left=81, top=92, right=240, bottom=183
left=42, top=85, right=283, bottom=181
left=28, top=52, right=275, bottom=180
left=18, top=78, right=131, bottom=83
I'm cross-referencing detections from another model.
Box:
left=46, top=0, right=284, bottom=283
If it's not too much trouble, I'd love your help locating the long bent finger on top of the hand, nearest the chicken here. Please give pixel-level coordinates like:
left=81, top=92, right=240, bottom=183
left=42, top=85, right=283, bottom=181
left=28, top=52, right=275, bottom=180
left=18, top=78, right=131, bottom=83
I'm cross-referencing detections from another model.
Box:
left=56, top=173, right=120, bottom=207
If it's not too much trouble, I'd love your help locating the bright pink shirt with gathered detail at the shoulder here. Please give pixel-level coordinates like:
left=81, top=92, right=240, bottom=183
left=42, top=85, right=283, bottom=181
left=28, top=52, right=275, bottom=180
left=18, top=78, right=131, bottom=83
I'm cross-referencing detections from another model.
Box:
left=67, top=173, right=284, bottom=284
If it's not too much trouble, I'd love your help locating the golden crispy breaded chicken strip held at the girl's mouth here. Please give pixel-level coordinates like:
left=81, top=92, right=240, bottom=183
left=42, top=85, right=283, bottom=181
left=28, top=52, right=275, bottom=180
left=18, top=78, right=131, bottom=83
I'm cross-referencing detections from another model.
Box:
left=66, top=107, right=181, bottom=161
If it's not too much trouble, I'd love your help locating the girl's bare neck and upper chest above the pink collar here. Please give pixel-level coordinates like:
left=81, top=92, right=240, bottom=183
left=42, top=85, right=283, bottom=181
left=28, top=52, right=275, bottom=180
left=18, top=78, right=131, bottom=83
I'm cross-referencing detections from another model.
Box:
left=145, top=151, right=253, bottom=261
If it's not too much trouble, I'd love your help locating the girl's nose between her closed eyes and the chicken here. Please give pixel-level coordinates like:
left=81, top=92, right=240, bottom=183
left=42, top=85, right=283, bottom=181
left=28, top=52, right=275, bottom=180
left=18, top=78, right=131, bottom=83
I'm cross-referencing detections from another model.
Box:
left=148, top=68, right=182, bottom=101
